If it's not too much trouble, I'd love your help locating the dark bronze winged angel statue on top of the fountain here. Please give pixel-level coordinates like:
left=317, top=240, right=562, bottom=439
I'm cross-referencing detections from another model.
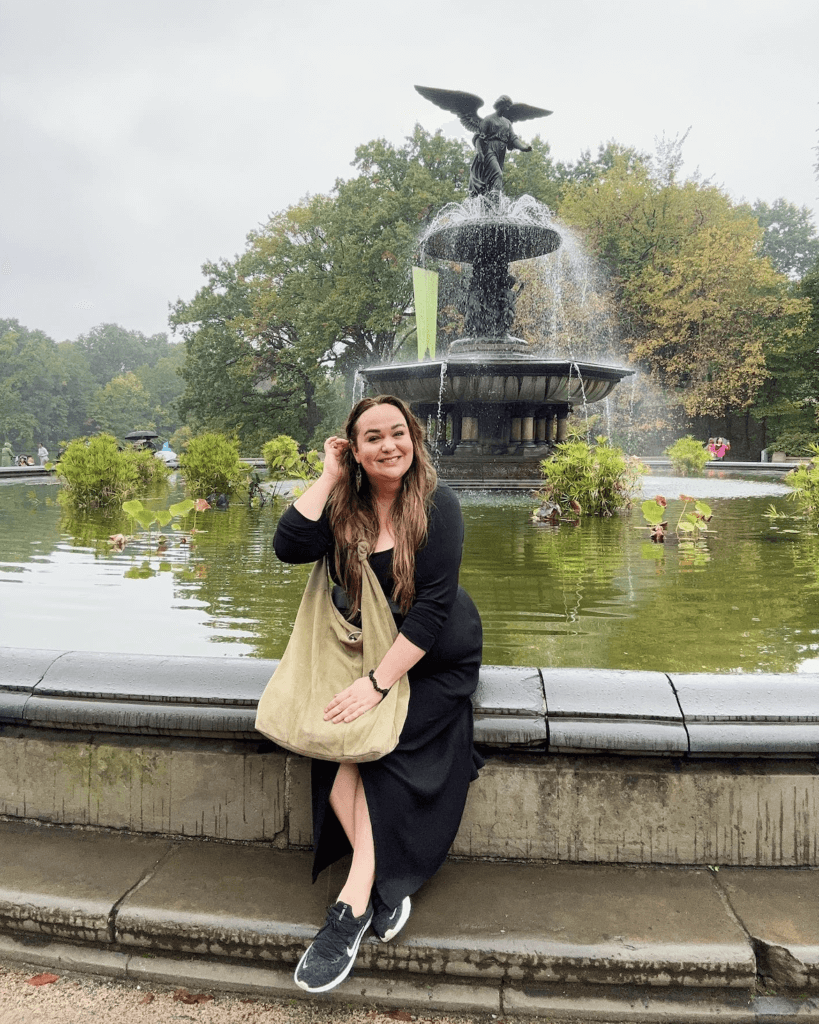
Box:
left=416, top=85, right=552, bottom=196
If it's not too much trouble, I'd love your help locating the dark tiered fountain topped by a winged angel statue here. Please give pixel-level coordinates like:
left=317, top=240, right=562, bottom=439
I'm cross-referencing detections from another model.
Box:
left=359, top=86, right=634, bottom=481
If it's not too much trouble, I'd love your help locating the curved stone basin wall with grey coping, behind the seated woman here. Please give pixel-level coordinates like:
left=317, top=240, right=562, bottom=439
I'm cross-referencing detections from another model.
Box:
left=0, top=648, right=819, bottom=867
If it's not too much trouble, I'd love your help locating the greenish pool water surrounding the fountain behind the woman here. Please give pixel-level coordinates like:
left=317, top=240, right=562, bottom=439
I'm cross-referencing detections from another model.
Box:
left=0, top=473, right=819, bottom=672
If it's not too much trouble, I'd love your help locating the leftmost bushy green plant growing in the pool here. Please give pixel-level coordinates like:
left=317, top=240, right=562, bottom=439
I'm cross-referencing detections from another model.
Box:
left=56, top=434, right=139, bottom=511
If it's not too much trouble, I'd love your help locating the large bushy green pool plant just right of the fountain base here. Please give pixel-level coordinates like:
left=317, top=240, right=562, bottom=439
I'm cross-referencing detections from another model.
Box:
left=541, top=436, right=646, bottom=516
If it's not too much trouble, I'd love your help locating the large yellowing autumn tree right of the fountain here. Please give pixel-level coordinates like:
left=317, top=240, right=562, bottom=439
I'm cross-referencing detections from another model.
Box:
left=561, top=150, right=806, bottom=416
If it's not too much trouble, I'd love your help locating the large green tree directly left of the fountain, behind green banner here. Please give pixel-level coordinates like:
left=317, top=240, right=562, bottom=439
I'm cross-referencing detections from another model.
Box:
left=171, top=127, right=469, bottom=443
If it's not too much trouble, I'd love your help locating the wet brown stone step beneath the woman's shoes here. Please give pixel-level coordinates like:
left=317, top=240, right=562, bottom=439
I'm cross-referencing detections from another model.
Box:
left=0, top=821, right=819, bottom=1022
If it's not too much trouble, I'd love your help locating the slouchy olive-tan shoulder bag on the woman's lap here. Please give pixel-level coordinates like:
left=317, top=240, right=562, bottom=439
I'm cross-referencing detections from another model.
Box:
left=256, top=542, right=410, bottom=761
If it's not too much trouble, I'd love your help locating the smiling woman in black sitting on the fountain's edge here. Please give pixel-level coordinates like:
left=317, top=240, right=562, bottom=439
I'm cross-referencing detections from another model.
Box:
left=273, top=395, right=483, bottom=992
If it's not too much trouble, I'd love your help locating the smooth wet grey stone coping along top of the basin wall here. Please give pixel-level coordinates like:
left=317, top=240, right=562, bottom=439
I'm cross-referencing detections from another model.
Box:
left=0, top=647, right=819, bottom=758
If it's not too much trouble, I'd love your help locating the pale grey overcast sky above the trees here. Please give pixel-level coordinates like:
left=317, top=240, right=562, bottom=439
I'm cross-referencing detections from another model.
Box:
left=0, top=0, right=819, bottom=341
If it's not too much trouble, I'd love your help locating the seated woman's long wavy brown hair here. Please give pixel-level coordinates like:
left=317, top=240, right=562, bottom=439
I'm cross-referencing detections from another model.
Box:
left=327, top=394, right=438, bottom=614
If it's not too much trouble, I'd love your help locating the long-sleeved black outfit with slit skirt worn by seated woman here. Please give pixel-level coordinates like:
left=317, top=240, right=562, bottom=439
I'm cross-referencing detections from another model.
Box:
left=273, top=483, right=483, bottom=907
